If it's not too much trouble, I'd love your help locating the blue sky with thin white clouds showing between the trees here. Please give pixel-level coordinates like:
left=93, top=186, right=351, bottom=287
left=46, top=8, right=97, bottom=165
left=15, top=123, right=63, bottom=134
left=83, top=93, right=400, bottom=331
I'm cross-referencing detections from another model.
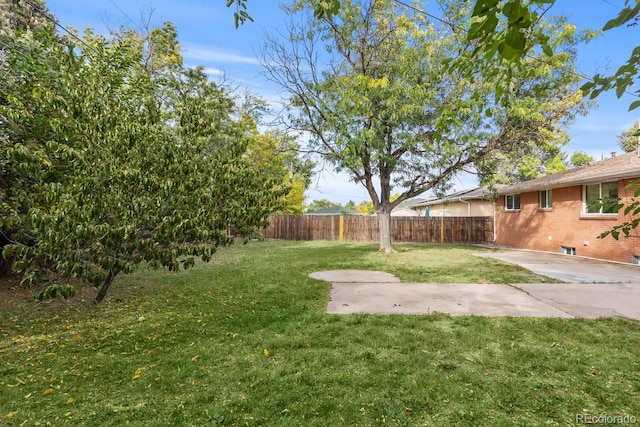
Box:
left=46, top=0, right=640, bottom=204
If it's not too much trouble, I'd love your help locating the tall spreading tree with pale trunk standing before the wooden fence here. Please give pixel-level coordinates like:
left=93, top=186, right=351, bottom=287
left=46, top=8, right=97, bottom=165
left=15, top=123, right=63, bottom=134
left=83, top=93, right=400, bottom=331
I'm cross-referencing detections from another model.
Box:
left=264, top=0, right=580, bottom=252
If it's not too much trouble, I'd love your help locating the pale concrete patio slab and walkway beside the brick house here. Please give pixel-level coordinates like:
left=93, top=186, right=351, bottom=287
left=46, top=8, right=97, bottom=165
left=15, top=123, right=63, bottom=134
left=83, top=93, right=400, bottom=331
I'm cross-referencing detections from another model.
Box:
left=310, top=252, right=640, bottom=320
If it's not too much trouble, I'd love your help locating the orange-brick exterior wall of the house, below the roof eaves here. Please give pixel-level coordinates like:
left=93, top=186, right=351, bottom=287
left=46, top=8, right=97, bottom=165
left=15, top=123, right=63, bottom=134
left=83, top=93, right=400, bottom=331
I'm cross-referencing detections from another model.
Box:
left=496, top=180, right=640, bottom=262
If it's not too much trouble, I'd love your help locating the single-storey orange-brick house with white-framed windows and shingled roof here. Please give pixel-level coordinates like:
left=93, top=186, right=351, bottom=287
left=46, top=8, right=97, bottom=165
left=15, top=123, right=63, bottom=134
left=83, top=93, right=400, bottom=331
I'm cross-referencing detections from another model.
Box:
left=495, top=152, right=640, bottom=264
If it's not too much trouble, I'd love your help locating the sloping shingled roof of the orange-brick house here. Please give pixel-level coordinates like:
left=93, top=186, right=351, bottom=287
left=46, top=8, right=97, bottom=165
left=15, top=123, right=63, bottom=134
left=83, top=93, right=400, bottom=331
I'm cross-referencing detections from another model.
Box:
left=498, top=151, right=640, bottom=194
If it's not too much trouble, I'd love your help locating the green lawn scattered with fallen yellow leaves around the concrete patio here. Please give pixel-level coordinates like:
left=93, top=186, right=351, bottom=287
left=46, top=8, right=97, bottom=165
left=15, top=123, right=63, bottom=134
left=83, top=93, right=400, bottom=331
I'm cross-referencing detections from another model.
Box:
left=0, top=242, right=640, bottom=426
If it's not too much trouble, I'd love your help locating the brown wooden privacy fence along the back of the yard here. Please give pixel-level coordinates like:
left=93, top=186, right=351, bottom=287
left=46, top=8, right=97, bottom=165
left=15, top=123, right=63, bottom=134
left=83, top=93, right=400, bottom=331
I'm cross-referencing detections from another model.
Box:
left=262, top=215, right=493, bottom=243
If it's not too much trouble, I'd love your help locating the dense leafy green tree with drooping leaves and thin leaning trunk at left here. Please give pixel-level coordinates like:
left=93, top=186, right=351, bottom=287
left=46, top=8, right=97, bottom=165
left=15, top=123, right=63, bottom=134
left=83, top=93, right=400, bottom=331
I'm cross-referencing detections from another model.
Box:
left=0, top=26, right=280, bottom=301
